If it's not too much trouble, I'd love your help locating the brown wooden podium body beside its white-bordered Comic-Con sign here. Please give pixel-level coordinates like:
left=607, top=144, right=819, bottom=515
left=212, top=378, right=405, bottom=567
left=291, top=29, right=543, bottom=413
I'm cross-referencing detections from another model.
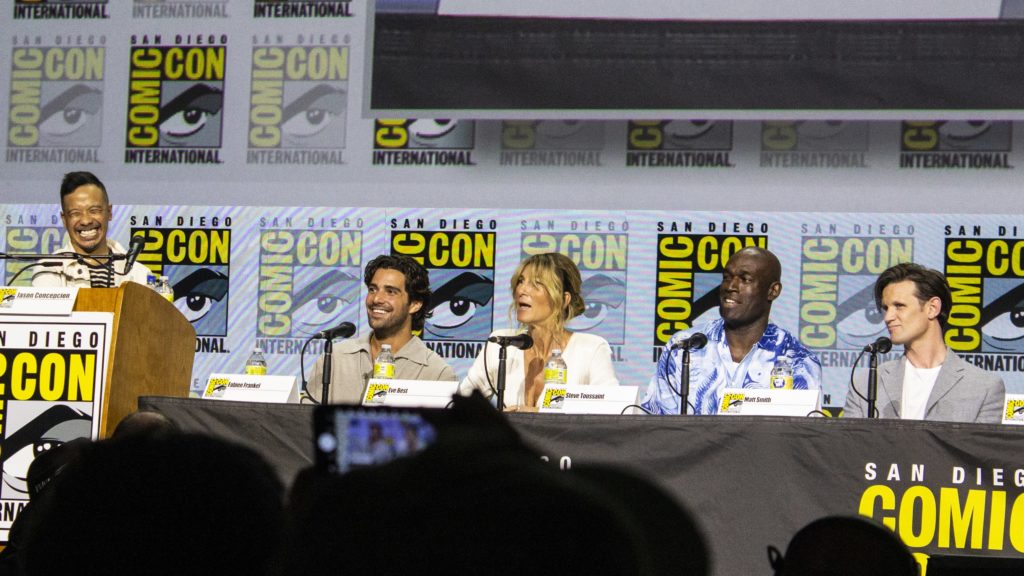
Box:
left=75, top=282, right=196, bottom=438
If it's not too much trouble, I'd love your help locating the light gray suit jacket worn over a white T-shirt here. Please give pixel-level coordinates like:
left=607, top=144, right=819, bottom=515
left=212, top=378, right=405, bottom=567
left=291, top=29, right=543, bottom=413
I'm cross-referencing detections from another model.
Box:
left=843, top=348, right=1006, bottom=423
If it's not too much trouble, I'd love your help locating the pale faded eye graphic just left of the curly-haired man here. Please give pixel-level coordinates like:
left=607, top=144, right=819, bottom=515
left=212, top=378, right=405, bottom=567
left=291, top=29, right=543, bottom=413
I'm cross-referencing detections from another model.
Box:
left=291, top=266, right=359, bottom=336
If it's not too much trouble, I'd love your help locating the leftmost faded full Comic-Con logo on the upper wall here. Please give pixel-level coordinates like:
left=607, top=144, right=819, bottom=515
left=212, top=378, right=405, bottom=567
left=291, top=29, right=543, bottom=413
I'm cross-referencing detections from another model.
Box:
left=6, top=36, right=106, bottom=163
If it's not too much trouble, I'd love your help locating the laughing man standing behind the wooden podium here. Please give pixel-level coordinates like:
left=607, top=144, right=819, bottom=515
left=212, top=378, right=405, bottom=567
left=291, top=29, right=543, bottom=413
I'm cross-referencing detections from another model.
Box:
left=32, top=172, right=152, bottom=288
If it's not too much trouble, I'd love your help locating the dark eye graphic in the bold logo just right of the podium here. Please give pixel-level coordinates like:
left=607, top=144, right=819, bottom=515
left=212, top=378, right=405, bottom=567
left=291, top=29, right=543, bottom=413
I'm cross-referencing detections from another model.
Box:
left=171, top=266, right=228, bottom=335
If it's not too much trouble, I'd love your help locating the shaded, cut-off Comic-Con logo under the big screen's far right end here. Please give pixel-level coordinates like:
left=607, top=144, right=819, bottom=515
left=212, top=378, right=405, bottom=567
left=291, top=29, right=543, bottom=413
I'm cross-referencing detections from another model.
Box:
left=899, top=120, right=1013, bottom=169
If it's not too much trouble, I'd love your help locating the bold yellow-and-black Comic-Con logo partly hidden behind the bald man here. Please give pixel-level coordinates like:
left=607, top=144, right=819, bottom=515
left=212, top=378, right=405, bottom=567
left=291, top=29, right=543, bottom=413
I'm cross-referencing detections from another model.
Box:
left=652, top=221, right=768, bottom=362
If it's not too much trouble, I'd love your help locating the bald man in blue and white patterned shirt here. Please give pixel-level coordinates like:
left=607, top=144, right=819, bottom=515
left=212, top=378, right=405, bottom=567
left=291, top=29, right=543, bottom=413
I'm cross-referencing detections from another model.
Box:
left=643, top=247, right=821, bottom=414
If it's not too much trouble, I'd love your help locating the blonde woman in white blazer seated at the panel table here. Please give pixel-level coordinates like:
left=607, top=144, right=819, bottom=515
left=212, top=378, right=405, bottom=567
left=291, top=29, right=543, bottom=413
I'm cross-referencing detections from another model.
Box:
left=459, top=252, right=618, bottom=411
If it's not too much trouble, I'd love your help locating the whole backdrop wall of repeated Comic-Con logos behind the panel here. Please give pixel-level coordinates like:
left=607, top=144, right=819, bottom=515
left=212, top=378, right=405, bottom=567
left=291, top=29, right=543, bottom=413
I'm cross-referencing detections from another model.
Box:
left=6, top=0, right=1024, bottom=407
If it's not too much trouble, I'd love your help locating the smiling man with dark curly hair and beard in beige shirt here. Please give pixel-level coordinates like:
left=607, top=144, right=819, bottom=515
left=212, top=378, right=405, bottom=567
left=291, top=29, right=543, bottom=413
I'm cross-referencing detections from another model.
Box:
left=308, top=254, right=456, bottom=404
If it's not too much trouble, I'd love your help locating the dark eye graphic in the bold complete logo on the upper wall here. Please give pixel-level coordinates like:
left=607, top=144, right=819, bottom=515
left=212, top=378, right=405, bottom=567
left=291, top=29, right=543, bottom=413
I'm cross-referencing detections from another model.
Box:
left=159, top=82, right=224, bottom=147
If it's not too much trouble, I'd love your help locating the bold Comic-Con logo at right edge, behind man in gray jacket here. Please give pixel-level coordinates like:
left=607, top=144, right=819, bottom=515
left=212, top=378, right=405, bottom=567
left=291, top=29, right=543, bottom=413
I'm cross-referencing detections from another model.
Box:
left=943, top=227, right=1024, bottom=362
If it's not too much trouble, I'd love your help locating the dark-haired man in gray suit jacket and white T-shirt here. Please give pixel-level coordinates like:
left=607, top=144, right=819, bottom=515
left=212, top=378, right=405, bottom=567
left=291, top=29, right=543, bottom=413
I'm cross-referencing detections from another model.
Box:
left=843, top=263, right=1006, bottom=423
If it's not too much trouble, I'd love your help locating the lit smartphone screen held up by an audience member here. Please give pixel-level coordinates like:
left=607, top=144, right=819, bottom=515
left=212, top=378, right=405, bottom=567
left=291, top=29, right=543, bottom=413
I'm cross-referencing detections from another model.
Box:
left=313, top=405, right=437, bottom=474
